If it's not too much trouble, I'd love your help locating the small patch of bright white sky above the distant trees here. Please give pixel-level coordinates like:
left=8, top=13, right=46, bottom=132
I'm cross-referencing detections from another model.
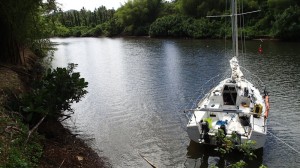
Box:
left=56, top=0, right=127, bottom=11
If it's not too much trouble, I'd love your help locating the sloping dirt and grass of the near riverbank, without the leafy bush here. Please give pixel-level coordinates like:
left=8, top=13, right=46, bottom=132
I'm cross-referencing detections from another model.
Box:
left=0, top=52, right=111, bottom=168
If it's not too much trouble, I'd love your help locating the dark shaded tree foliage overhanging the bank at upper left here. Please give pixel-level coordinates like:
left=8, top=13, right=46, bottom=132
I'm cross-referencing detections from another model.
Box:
left=0, top=0, right=56, bottom=64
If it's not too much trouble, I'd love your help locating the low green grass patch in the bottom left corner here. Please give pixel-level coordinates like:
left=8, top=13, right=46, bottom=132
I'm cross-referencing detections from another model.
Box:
left=0, top=107, right=43, bottom=168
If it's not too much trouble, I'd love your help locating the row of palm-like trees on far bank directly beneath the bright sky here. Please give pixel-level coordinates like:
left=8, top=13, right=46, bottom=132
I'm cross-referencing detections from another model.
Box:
left=46, top=6, right=115, bottom=37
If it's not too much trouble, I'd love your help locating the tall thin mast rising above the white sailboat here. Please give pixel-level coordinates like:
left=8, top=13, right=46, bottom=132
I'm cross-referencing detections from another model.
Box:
left=231, top=0, right=239, bottom=57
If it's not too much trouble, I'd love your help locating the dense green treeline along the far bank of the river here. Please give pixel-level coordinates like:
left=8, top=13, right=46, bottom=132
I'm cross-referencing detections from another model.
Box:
left=46, top=0, right=300, bottom=40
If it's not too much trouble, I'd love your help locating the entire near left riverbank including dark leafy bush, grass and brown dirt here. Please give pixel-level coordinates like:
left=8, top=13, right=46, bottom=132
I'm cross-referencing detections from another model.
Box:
left=0, top=61, right=109, bottom=168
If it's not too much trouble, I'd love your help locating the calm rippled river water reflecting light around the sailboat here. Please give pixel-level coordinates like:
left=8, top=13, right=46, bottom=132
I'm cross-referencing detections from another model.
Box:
left=52, top=38, right=300, bottom=168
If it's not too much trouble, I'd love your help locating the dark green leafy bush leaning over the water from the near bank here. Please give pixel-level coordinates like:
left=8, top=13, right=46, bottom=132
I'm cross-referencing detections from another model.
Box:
left=21, top=64, right=88, bottom=123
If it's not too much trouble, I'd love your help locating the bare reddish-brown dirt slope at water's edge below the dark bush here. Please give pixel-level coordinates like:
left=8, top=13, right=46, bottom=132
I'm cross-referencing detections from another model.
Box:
left=39, top=121, right=111, bottom=168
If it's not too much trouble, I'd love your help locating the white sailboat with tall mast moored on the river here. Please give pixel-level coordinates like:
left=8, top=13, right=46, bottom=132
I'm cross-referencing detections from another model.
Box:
left=185, top=0, right=270, bottom=149
